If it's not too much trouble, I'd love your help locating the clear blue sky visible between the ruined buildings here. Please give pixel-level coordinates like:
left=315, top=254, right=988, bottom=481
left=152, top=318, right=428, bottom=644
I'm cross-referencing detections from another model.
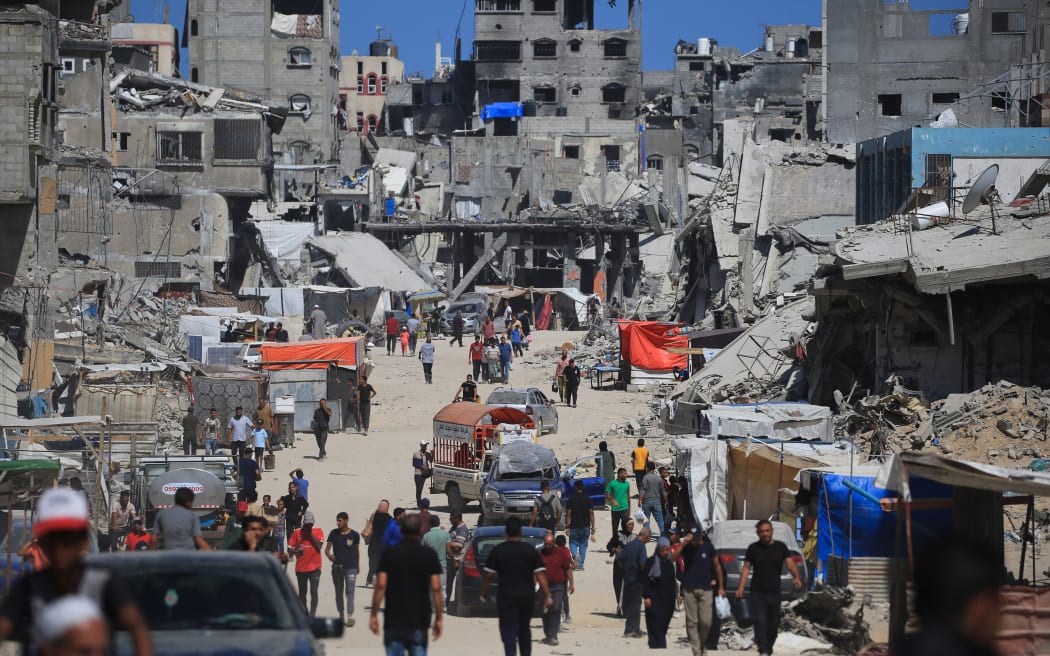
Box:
left=131, top=0, right=823, bottom=77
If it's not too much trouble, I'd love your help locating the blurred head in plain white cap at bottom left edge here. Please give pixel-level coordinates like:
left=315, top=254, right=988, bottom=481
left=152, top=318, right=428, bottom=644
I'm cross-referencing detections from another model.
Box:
left=35, top=595, right=109, bottom=656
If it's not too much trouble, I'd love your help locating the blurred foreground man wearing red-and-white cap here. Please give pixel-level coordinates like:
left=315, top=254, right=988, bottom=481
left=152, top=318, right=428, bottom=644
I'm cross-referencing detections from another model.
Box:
left=0, top=488, right=153, bottom=656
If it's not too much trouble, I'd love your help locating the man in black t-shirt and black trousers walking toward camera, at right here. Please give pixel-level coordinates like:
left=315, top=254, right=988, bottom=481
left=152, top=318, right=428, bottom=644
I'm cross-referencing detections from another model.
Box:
left=736, top=520, right=802, bottom=655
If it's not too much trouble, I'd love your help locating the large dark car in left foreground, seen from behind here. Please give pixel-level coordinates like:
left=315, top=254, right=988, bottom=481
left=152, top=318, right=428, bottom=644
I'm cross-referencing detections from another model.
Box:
left=87, top=551, right=343, bottom=656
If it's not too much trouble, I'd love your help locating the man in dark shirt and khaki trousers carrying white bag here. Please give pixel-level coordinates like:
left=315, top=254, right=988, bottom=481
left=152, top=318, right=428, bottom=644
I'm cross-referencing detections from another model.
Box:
left=681, top=529, right=726, bottom=656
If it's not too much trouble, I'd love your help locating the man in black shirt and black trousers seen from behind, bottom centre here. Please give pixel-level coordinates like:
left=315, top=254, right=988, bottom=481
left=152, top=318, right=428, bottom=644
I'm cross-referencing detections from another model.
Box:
left=481, top=517, right=553, bottom=656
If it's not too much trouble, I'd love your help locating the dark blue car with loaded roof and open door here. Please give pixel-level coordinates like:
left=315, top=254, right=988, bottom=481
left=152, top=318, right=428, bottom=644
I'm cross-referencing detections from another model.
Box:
left=478, top=441, right=605, bottom=526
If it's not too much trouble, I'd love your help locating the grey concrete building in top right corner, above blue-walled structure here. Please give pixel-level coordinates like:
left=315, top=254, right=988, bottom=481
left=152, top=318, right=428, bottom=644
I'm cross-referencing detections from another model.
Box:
left=823, top=0, right=1050, bottom=143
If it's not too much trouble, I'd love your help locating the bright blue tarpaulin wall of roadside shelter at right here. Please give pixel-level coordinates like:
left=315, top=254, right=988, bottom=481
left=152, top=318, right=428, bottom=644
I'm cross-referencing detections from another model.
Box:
left=817, top=473, right=952, bottom=563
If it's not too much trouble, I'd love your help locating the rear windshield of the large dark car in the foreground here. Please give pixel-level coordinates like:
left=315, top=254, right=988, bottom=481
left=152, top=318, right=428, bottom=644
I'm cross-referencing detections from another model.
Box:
left=121, top=566, right=297, bottom=631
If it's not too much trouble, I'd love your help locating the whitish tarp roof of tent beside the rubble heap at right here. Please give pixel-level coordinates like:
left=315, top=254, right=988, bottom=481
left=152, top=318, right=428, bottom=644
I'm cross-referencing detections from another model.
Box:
left=700, top=402, right=835, bottom=442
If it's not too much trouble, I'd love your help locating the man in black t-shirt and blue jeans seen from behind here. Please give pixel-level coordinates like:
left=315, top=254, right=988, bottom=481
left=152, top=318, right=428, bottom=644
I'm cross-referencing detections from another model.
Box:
left=369, top=514, right=443, bottom=654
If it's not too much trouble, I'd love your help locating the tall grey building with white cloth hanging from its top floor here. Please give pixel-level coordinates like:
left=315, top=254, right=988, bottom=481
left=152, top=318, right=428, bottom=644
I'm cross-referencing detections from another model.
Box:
left=183, top=0, right=340, bottom=200
